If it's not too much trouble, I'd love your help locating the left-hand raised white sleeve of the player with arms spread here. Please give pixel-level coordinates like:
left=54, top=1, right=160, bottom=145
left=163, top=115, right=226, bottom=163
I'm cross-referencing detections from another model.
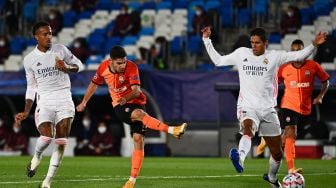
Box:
left=203, top=38, right=237, bottom=66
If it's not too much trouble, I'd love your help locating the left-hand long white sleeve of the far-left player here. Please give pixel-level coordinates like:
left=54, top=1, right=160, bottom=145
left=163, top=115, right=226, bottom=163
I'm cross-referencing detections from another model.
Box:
left=23, top=59, right=37, bottom=101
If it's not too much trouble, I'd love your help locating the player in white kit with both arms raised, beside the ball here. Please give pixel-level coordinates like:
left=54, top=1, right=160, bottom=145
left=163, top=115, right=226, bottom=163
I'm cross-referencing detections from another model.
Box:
left=202, top=27, right=326, bottom=187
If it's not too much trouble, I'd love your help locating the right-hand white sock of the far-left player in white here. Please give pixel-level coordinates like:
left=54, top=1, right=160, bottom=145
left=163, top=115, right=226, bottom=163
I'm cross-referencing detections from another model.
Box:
left=44, top=138, right=67, bottom=184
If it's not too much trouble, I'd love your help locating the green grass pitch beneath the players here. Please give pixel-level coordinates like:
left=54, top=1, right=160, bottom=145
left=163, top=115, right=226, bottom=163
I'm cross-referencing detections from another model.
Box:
left=0, top=156, right=336, bottom=188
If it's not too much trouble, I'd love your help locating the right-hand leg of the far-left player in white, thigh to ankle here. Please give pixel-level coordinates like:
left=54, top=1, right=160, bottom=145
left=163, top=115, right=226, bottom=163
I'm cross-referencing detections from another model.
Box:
left=41, top=117, right=73, bottom=188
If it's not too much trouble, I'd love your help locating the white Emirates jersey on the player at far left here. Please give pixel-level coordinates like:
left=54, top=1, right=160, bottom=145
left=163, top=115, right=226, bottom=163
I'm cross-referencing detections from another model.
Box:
left=23, top=44, right=83, bottom=103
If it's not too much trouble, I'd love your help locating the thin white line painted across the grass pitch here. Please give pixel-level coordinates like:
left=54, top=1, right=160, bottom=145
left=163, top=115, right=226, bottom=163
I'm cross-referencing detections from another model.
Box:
left=0, top=172, right=336, bottom=184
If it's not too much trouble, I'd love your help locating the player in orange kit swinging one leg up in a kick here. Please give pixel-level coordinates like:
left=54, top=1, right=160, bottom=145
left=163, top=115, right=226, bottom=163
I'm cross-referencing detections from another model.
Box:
left=76, top=46, right=187, bottom=188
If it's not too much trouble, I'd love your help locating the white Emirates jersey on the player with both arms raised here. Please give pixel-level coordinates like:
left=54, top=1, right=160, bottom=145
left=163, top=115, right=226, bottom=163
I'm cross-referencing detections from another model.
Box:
left=203, top=38, right=314, bottom=109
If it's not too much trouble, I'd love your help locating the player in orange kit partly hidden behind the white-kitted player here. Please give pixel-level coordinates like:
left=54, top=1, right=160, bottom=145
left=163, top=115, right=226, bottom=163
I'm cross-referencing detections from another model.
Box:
left=257, top=40, right=329, bottom=173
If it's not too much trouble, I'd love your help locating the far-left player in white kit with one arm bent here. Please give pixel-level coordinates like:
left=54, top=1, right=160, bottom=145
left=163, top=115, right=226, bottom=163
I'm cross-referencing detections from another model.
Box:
left=15, top=22, right=83, bottom=188
